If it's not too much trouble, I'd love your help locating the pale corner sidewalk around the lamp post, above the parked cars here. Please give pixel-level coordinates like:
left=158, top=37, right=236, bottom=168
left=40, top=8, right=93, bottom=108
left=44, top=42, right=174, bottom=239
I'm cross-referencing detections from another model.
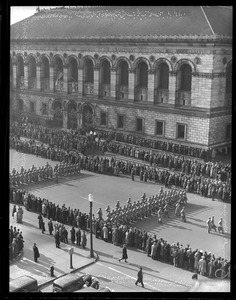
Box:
left=10, top=204, right=98, bottom=287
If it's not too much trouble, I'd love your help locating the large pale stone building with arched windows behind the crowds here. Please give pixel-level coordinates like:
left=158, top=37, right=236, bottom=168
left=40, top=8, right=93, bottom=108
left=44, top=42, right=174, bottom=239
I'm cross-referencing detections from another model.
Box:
left=10, top=7, right=232, bottom=149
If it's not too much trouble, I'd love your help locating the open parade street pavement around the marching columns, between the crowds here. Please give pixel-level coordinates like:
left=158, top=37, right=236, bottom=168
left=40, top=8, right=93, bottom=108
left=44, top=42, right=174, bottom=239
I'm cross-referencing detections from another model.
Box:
left=10, top=150, right=231, bottom=258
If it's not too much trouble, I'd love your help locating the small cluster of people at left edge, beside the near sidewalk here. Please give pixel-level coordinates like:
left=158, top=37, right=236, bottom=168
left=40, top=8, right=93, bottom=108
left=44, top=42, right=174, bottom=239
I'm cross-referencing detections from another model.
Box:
left=9, top=225, right=24, bottom=261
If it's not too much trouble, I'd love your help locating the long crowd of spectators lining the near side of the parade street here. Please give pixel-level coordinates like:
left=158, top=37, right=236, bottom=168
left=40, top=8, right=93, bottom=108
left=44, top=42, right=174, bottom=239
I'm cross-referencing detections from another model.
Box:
left=10, top=188, right=230, bottom=278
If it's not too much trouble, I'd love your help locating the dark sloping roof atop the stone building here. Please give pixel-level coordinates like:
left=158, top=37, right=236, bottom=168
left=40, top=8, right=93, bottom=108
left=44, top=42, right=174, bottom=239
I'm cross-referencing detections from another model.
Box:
left=11, top=6, right=233, bottom=40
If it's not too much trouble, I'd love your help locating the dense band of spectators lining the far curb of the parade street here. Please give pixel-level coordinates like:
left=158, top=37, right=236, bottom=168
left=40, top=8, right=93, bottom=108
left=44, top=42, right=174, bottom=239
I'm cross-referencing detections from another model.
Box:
left=10, top=136, right=231, bottom=202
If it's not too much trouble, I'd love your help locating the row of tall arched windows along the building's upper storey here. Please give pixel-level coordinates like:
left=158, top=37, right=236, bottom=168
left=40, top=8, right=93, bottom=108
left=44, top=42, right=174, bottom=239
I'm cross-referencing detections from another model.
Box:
left=11, top=55, right=232, bottom=104
